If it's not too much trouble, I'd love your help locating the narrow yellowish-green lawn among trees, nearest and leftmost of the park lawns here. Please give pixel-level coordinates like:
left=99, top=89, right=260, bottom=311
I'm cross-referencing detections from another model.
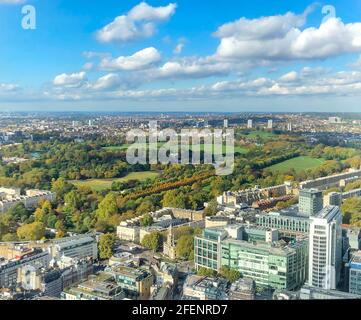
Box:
left=70, top=171, right=159, bottom=191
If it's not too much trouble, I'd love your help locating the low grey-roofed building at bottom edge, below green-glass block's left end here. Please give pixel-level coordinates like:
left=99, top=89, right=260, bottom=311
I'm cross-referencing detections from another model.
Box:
left=182, top=275, right=228, bottom=300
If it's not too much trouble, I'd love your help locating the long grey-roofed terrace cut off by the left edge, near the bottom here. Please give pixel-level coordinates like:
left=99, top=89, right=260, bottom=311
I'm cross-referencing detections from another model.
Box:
left=0, top=248, right=51, bottom=288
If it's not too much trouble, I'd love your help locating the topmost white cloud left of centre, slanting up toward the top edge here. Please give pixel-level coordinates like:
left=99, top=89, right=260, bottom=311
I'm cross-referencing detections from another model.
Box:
left=97, top=2, right=177, bottom=43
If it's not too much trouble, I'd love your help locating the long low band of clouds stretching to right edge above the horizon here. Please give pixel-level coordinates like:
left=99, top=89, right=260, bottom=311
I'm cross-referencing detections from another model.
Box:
left=48, top=68, right=361, bottom=100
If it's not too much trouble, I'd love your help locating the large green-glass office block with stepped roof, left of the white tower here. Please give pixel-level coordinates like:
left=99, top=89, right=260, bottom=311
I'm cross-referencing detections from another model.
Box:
left=194, top=225, right=308, bottom=290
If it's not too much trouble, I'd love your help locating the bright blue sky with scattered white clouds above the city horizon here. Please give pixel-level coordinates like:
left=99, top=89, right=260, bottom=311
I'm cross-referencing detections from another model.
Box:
left=0, top=0, right=361, bottom=112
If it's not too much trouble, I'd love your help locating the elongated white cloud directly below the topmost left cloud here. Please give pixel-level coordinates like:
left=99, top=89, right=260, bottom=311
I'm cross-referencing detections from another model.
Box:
left=99, top=47, right=161, bottom=71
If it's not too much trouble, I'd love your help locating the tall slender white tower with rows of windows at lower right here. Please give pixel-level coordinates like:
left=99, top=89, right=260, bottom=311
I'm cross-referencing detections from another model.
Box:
left=308, top=206, right=342, bottom=290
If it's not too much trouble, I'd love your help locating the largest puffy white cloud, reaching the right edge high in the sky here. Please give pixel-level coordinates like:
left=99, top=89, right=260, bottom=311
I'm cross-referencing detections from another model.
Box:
left=216, top=14, right=361, bottom=61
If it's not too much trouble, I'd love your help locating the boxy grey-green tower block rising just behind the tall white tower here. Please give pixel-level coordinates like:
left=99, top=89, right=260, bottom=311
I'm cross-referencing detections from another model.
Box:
left=298, top=189, right=323, bottom=216
